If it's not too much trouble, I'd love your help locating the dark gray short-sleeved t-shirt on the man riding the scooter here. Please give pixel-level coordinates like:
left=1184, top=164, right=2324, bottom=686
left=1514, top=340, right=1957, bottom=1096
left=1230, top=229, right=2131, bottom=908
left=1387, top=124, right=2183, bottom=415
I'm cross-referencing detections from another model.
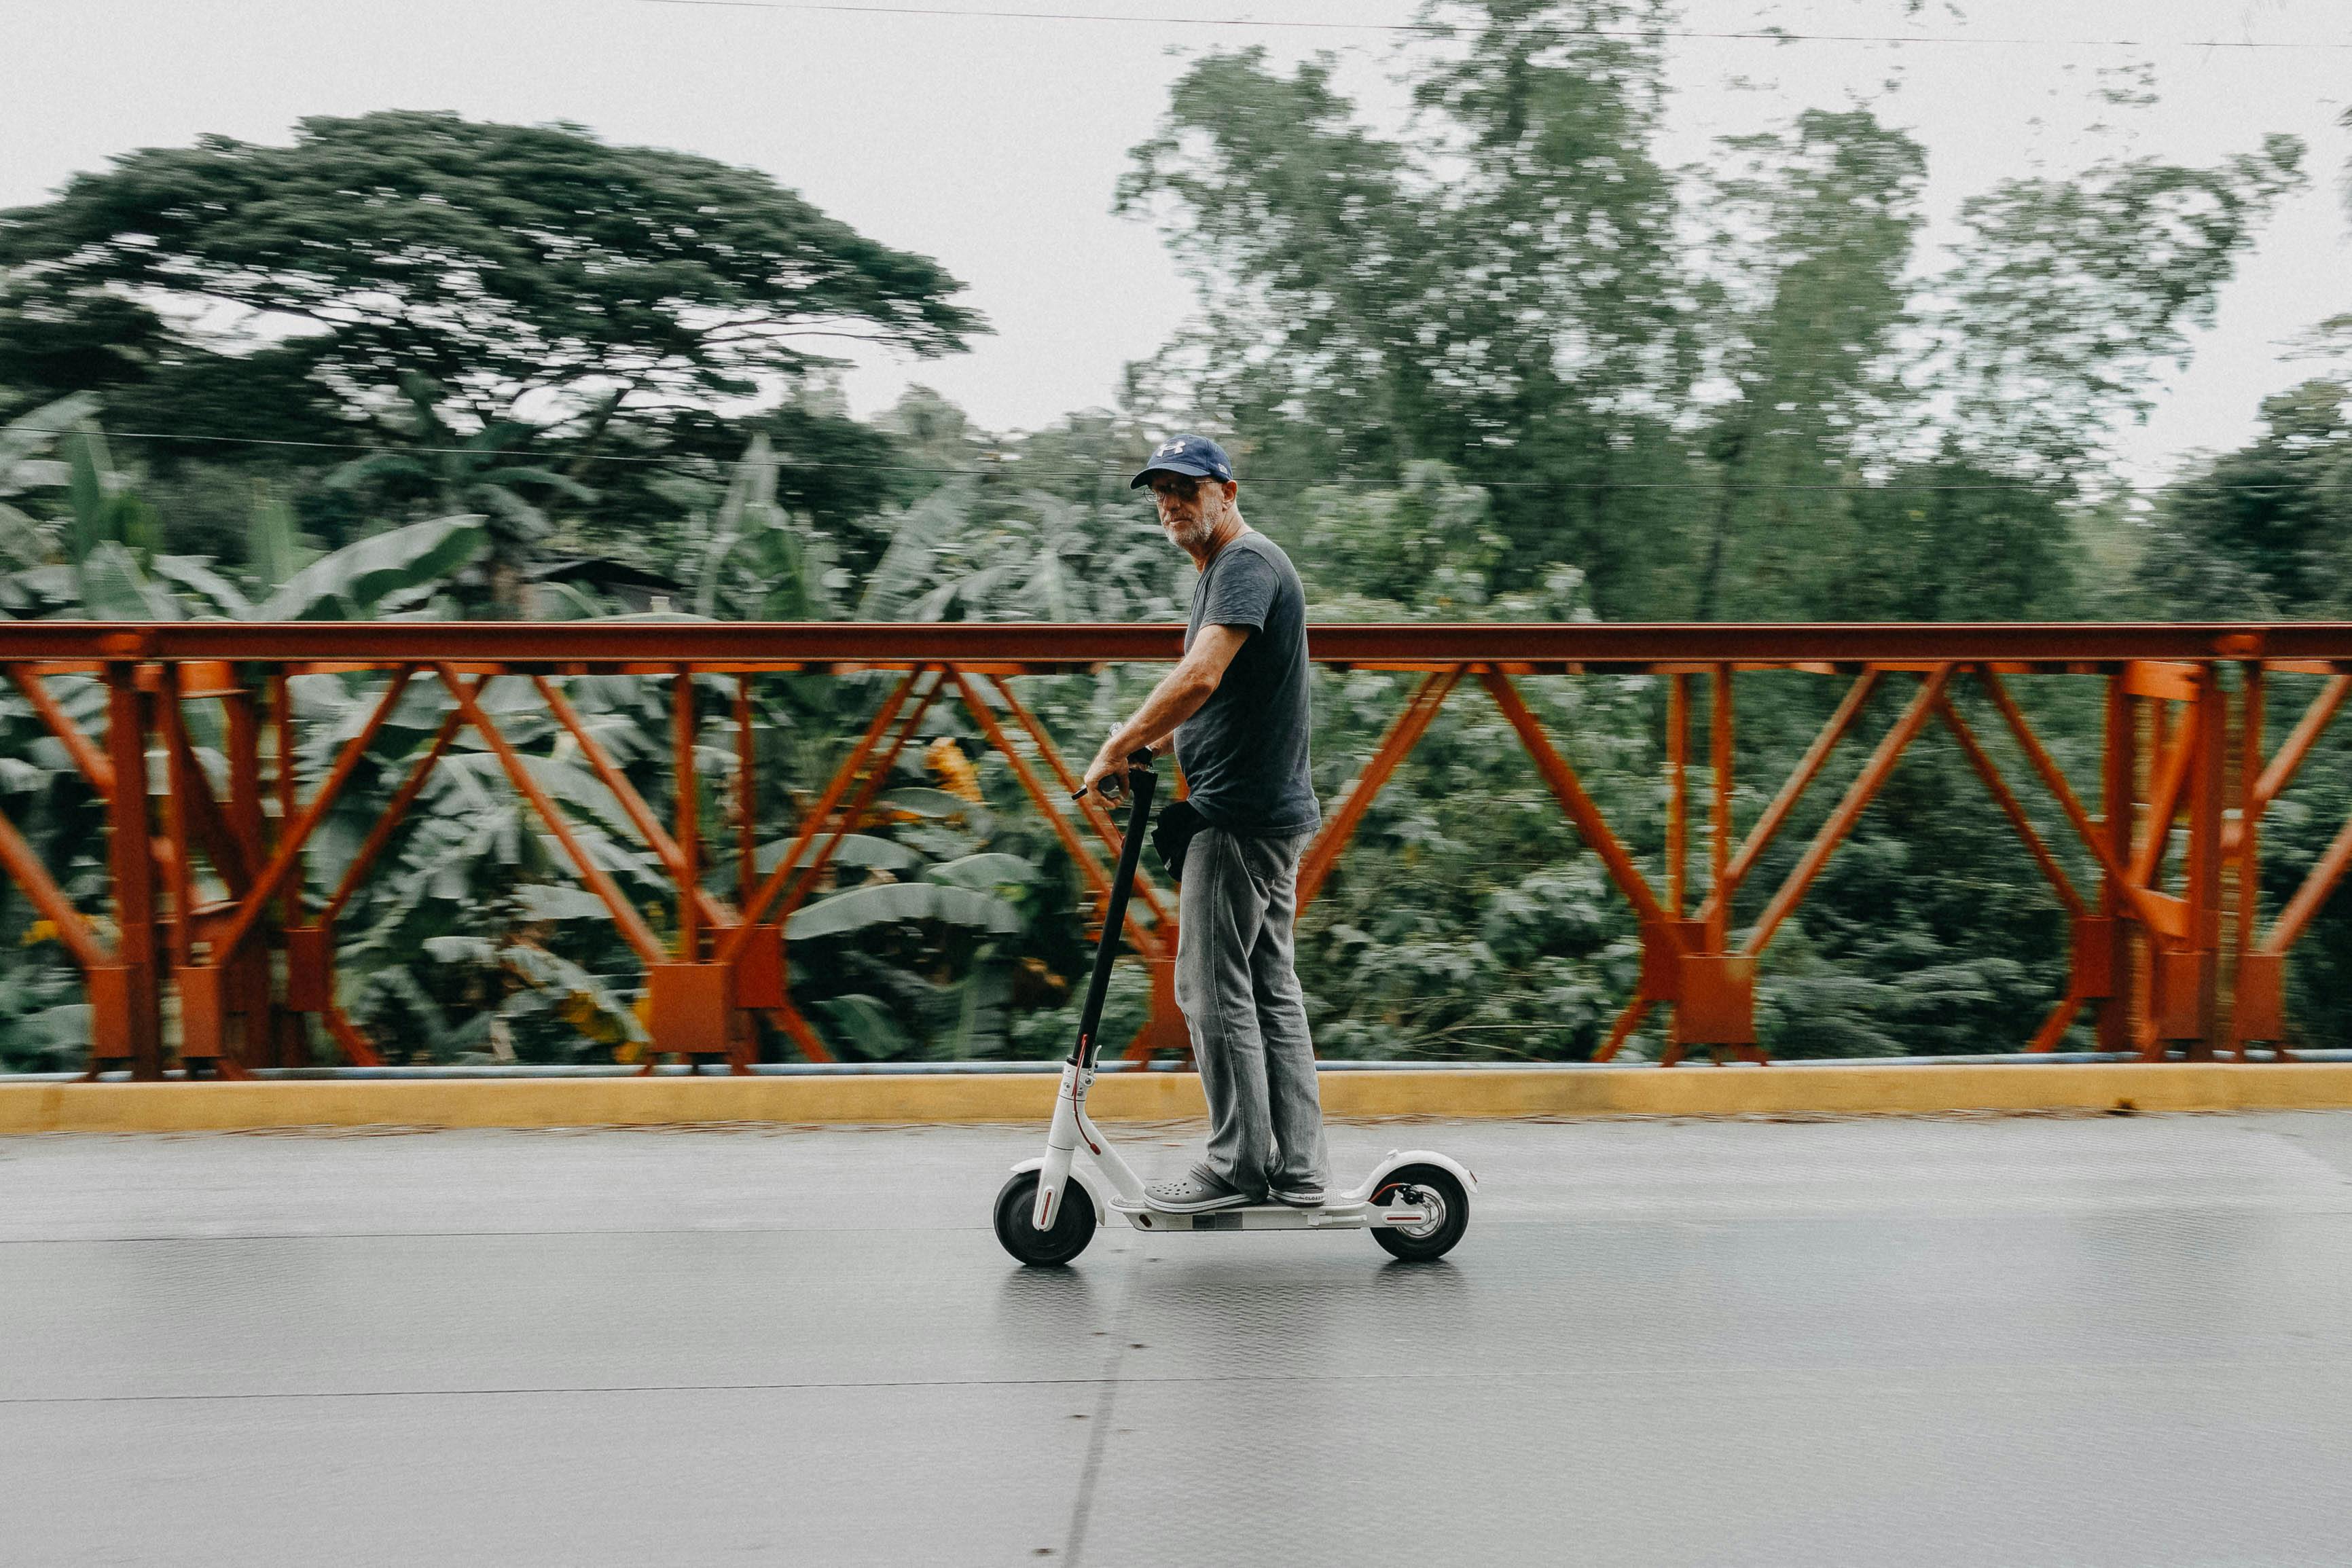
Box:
left=1176, top=534, right=1322, bottom=837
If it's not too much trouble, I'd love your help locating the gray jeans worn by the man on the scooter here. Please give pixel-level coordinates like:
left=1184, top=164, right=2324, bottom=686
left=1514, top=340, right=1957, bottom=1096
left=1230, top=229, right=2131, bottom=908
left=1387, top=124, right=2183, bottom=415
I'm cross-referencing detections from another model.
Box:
left=1176, top=828, right=1324, bottom=1197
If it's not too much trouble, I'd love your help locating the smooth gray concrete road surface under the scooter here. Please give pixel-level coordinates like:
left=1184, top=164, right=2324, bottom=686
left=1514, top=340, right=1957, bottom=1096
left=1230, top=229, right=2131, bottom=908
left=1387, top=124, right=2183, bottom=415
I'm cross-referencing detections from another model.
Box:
left=0, top=1114, right=2352, bottom=1568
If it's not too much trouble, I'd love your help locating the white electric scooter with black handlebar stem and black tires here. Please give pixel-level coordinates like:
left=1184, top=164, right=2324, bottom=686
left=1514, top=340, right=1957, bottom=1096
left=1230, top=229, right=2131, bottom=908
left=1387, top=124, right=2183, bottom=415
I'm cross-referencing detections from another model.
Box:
left=997, top=752, right=1477, bottom=1267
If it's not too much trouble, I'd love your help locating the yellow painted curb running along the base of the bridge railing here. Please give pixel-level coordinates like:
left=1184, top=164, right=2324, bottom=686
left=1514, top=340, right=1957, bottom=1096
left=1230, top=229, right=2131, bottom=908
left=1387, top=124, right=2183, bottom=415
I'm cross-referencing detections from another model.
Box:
left=0, top=1063, right=2352, bottom=1133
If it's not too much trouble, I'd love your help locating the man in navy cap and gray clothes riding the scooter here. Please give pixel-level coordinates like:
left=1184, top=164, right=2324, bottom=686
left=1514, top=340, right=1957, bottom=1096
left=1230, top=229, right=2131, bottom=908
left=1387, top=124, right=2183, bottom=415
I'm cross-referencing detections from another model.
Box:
left=1087, top=435, right=1324, bottom=1213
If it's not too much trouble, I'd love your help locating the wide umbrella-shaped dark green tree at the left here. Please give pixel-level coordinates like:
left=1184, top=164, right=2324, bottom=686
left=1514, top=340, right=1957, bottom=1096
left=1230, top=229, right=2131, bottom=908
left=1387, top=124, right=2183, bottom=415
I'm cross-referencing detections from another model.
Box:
left=0, top=113, right=983, bottom=447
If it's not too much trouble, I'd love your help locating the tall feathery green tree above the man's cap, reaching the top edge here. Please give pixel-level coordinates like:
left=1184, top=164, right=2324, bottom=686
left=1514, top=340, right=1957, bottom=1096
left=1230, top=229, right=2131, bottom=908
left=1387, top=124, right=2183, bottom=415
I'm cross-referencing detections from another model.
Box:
left=1119, top=0, right=1691, bottom=604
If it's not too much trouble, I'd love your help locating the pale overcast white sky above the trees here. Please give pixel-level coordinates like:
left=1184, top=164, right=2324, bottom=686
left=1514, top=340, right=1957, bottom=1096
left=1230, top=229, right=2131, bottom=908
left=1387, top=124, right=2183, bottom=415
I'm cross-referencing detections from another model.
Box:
left=0, top=0, right=2352, bottom=484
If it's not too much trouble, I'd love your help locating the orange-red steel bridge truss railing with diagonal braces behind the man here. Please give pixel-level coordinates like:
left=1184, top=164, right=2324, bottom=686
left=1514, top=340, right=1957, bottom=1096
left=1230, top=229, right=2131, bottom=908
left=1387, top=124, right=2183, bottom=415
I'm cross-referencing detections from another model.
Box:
left=0, top=623, right=2352, bottom=1079
